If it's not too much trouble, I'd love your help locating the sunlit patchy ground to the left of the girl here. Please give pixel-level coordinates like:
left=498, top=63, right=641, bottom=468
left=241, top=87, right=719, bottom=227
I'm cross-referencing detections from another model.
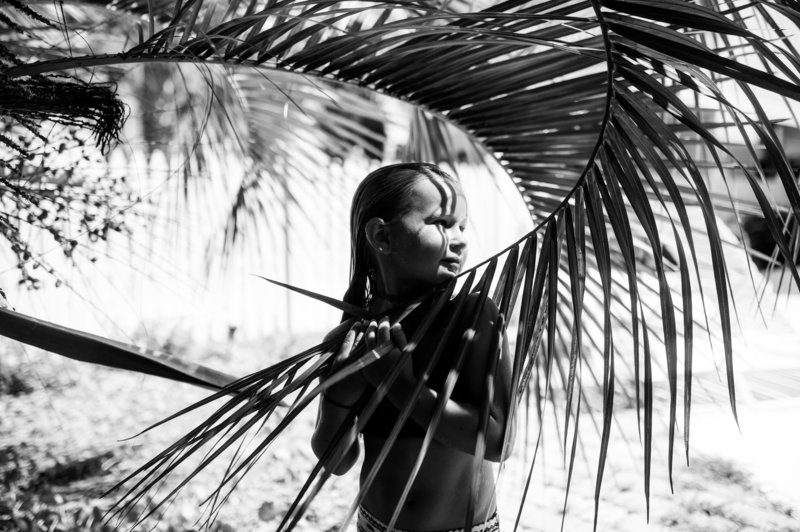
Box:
left=0, top=334, right=340, bottom=532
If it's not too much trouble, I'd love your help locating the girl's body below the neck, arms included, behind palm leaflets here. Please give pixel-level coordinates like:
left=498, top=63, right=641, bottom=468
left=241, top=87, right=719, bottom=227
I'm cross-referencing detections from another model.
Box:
left=312, top=296, right=513, bottom=531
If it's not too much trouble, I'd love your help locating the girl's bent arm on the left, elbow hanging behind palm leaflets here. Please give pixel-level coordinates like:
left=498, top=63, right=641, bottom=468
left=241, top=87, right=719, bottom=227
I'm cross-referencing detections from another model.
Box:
left=311, top=321, right=366, bottom=475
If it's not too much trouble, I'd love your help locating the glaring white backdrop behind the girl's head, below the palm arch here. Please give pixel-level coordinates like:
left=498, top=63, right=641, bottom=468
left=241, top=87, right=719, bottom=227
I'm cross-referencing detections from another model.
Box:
left=0, top=152, right=531, bottom=347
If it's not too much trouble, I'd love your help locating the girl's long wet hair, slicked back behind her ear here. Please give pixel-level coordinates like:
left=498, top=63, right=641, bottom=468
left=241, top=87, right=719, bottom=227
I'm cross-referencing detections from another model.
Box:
left=344, top=162, right=458, bottom=307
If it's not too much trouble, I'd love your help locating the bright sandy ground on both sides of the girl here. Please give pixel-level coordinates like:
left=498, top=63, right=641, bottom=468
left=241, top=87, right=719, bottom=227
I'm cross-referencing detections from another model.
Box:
left=0, top=328, right=800, bottom=531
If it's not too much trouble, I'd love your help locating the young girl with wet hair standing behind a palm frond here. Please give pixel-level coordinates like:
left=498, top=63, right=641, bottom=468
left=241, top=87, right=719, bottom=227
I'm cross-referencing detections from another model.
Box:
left=311, top=163, right=513, bottom=532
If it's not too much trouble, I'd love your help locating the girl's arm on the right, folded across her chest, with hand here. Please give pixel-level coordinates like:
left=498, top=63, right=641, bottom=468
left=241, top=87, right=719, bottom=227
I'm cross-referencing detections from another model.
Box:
left=363, top=300, right=514, bottom=462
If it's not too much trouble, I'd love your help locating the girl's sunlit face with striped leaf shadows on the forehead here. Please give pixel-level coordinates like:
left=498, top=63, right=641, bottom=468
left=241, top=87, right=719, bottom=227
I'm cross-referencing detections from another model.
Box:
left=383, top=179, right=467, bottom=294
